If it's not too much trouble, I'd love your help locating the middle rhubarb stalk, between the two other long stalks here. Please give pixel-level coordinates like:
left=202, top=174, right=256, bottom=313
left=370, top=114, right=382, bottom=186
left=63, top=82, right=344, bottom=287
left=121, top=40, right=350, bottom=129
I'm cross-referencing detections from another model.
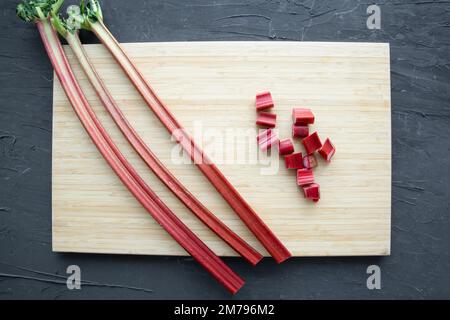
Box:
left=52, top=20, right=262, bottom=265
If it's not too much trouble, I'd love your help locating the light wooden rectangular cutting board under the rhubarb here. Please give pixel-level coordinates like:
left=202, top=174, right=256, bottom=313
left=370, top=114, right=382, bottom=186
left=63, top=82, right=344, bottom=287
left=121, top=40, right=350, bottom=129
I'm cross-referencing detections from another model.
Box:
left=52, top=42, right=391, bottom=256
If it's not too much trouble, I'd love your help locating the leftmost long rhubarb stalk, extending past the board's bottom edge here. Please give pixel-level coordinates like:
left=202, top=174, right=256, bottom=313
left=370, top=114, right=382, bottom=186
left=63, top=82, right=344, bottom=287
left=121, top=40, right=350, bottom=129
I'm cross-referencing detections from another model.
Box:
left=17, top=1, right=244, bottom=293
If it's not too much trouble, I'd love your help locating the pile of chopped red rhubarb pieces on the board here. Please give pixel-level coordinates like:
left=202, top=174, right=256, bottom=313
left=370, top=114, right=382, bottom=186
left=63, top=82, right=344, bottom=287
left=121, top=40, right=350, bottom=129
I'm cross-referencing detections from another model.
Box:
left=256, top=92, right=336, bottom=202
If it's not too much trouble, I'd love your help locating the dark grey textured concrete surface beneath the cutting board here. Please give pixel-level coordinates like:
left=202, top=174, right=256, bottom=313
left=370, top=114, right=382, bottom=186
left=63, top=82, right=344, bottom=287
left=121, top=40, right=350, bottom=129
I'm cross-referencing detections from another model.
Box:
left=0, top=0, right=450, bottom=299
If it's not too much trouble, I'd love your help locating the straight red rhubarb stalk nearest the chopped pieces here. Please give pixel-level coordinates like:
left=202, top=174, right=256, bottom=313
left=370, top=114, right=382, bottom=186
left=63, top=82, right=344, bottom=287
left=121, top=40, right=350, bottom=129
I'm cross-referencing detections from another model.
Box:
left=82, top=0, right=291, bottom=262
